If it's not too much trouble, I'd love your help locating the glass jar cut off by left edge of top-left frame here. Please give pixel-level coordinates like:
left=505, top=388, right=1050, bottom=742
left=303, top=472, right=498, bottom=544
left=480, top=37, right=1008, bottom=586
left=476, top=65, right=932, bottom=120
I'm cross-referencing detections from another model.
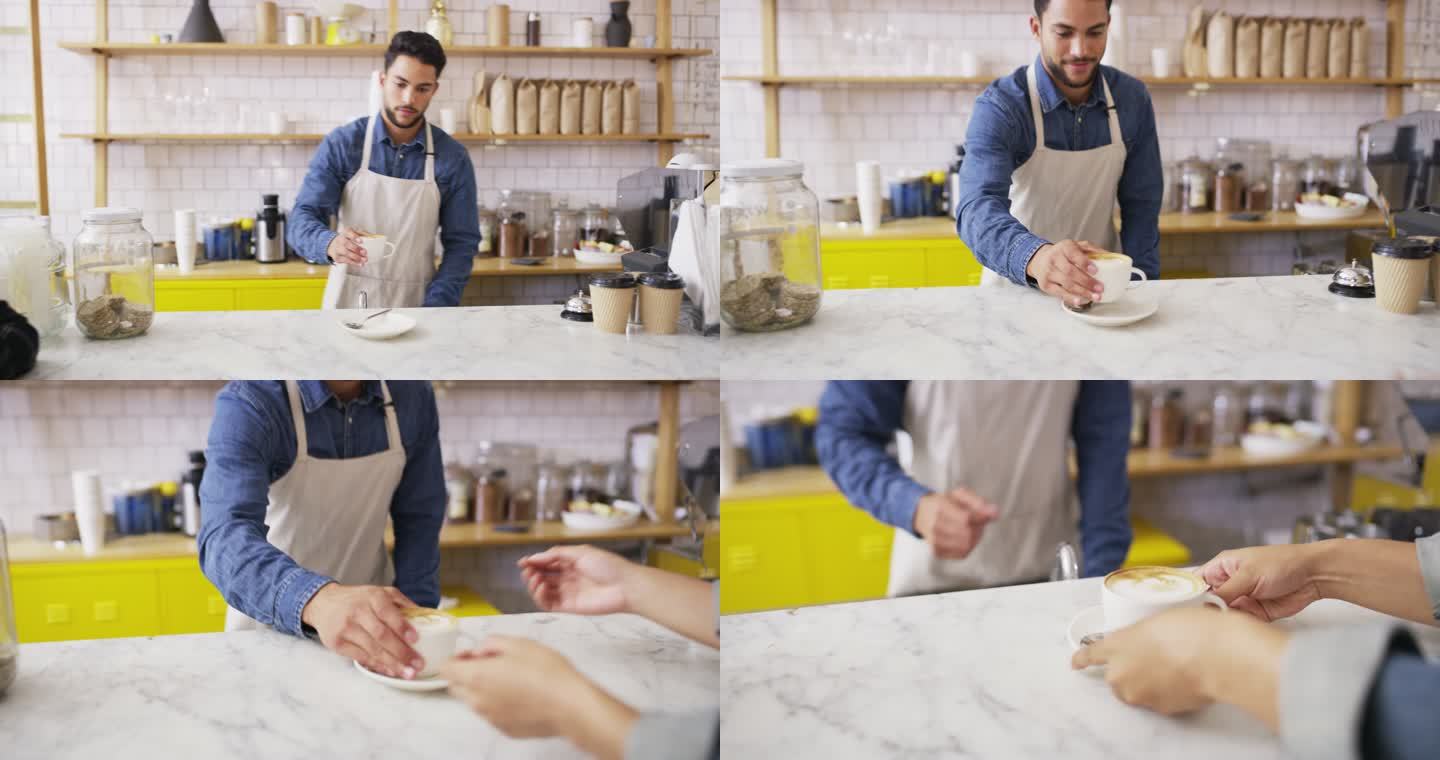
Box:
left=0, top=217, right=71, bottom=338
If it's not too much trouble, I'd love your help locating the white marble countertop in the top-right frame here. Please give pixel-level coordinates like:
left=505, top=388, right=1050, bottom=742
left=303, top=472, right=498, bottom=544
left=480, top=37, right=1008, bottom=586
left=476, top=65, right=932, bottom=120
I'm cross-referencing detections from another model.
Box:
left=721, top=275, right=1440, bottom=380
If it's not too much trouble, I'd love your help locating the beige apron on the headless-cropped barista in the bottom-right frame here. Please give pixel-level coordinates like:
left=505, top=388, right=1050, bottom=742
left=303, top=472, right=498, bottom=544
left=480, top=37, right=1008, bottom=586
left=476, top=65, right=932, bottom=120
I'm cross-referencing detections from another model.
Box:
left=888, top=381, right=1080, bottom=596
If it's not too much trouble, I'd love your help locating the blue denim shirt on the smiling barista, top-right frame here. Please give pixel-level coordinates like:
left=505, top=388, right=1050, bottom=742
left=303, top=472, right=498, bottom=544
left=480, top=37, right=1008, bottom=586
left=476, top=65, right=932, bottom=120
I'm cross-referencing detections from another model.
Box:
left=956, top=58, right=1165, bottom=285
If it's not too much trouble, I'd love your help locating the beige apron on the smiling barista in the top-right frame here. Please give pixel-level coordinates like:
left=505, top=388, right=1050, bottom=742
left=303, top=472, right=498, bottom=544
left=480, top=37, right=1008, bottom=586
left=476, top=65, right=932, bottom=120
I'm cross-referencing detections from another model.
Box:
left=981, top=63, right=1125, bottom=285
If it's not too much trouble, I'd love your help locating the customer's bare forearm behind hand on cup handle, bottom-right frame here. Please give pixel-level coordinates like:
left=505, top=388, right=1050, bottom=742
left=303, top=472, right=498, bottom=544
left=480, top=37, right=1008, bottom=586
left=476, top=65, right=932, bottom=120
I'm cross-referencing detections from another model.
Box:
left=1309, top=538, right=1436, bottom=625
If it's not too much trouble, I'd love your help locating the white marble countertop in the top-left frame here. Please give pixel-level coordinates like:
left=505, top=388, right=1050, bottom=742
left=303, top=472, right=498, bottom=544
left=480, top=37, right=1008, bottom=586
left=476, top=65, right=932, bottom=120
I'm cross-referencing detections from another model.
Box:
left=24, top=305, right=720, bottom=380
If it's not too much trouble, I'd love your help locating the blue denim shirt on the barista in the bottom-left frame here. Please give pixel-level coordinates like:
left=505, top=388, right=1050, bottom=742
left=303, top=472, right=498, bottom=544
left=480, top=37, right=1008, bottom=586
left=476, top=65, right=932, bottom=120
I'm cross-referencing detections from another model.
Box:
left=197, top=380, right=445, bottom=636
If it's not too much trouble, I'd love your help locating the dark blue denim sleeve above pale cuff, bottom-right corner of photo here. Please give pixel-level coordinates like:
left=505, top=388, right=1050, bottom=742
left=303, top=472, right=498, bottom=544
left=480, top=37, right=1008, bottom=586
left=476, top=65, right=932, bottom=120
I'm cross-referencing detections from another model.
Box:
left=1359, top=636, right=1440, bottom=760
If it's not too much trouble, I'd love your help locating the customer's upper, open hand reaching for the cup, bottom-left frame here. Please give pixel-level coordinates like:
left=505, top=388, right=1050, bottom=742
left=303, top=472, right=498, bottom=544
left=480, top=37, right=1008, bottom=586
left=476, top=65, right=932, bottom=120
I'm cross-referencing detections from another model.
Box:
left=520, top=546, right=638, bottom=615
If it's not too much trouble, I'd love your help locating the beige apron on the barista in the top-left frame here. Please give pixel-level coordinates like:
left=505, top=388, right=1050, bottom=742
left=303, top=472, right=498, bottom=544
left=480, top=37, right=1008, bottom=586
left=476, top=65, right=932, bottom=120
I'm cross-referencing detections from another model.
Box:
left=321, top=117, right=441, bottom=308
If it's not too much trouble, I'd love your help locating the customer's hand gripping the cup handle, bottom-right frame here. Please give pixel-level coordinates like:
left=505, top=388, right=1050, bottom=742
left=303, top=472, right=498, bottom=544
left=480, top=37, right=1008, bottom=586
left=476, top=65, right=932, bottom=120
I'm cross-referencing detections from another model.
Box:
left=1200, top=544, right=1320, bottom=622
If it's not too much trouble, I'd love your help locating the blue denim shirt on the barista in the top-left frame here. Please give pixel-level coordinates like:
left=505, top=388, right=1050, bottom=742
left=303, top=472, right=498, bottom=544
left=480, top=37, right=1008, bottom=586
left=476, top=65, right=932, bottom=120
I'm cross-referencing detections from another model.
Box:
left=285, top=114, right=480, bottom=307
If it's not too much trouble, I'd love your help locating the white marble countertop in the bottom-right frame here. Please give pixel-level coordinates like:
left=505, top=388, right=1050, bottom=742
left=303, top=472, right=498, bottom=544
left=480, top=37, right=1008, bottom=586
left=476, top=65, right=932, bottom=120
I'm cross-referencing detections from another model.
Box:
left=720, top=579, right=1440, bottom=760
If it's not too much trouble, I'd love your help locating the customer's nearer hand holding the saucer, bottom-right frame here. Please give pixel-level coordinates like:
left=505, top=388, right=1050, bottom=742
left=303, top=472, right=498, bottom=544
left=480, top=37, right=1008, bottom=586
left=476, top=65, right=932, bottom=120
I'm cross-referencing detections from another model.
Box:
left=1070, top=607, right=1290, bottom=728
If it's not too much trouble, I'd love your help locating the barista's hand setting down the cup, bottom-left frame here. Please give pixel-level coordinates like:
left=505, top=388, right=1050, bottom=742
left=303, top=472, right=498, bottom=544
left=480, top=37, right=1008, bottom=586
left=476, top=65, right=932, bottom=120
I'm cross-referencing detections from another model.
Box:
left=300, top=583, right=425, bottom=678
